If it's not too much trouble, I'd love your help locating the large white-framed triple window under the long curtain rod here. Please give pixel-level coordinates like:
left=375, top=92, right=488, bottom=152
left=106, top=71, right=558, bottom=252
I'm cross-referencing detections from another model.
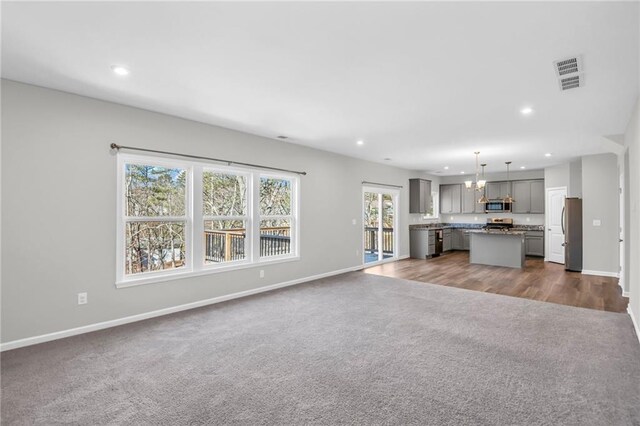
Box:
left=116, top=154, right=298, bottom=287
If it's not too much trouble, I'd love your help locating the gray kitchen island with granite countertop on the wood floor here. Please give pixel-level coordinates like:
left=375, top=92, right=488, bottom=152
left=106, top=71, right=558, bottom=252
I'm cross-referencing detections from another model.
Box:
left=467, top=230, right=526, bottom=268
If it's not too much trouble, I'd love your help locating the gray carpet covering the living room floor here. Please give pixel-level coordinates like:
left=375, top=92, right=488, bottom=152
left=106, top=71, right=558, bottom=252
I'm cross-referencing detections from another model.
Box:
left=2, top=272, right=640, bottom=425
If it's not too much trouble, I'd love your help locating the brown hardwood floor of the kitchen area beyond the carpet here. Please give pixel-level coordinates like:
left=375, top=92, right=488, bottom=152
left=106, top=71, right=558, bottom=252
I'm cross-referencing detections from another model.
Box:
left=364, top=251, right=629, bottom=312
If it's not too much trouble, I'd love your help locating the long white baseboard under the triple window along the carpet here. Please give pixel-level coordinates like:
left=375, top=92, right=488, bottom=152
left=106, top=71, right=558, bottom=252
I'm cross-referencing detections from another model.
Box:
left=0, top=265, right=362, bottom=352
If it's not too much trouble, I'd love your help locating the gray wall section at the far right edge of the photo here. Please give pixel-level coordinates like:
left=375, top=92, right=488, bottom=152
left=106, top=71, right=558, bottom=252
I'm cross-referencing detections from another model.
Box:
left=624, top=95, right=640, bottom=325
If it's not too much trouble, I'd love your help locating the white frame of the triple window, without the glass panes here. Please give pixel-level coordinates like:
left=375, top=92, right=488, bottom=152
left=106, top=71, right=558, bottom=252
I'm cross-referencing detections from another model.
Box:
left=116, top=153, right=300, bottom=288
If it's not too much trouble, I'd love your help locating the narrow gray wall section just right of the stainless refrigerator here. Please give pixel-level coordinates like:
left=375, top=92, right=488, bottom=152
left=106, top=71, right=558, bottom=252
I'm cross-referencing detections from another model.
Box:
left=582, top=154, right=619, bottom=274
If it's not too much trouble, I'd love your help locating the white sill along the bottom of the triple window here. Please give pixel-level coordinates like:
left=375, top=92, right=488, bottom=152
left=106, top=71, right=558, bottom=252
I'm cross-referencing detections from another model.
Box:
left=116, top=255, right=300, bottom=288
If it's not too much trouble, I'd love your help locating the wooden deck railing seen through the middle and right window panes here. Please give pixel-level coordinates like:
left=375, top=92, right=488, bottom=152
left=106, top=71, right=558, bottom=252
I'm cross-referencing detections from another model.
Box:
left=204, top=227, right=291, bottom=262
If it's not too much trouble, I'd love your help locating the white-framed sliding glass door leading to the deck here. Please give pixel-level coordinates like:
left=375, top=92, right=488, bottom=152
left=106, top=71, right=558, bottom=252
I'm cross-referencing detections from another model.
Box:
left=362, top=187, right=399, bottom=263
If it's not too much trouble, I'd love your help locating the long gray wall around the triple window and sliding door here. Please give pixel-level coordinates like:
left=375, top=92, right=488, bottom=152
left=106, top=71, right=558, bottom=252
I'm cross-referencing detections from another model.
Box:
left=1, top=80, right=412, bottom=343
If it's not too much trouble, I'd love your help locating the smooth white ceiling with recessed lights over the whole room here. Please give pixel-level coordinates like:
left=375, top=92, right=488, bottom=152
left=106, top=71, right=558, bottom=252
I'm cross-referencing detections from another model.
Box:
left=2, top=2, right=640, bottom=175
